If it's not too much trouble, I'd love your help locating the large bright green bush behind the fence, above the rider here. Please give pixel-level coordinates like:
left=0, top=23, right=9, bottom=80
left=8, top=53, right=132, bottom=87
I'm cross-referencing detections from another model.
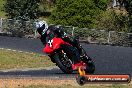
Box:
left=51, top=0, right=107, bottom=28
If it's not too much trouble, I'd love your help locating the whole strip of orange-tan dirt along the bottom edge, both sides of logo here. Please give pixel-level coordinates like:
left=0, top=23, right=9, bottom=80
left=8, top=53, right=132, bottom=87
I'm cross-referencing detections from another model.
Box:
left=0, top=78, right=132, bottom=88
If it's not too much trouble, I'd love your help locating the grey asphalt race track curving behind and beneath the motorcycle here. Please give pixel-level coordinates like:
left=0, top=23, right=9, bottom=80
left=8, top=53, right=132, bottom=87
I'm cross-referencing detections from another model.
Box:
left=0, top=36, right=132, bottom=77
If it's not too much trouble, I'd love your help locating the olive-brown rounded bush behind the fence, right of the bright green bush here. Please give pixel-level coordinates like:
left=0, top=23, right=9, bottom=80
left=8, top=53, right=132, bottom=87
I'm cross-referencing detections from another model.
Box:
left=95, top=9, right=129, bottom=32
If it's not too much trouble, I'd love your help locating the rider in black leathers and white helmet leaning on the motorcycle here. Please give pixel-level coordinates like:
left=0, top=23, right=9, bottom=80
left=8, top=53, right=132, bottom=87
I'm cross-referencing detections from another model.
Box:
left=36, top=21, right=91, bottom=70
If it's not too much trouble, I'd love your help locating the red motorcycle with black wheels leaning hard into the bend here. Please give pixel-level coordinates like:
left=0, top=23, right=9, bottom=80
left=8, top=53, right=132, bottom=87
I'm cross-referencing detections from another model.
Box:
left=43, top=37, right=95, bottom=73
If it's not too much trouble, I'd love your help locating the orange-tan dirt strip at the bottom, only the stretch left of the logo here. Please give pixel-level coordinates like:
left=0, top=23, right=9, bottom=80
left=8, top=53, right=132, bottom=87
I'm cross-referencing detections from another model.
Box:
left=0, top=78, right=77, bottom=88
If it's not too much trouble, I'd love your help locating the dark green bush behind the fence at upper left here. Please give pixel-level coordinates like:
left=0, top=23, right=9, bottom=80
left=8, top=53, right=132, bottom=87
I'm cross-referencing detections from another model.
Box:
left=5, top=0, right=40, bottom=20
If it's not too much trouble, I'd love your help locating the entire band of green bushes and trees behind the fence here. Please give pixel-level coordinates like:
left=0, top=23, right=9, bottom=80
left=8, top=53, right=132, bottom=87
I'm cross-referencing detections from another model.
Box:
left=0, top=0, right=132, bottom=32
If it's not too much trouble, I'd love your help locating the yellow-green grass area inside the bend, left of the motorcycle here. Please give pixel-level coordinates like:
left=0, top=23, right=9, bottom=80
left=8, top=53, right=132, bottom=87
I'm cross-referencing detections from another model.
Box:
left=0, top=49, right=54, bottom=70
